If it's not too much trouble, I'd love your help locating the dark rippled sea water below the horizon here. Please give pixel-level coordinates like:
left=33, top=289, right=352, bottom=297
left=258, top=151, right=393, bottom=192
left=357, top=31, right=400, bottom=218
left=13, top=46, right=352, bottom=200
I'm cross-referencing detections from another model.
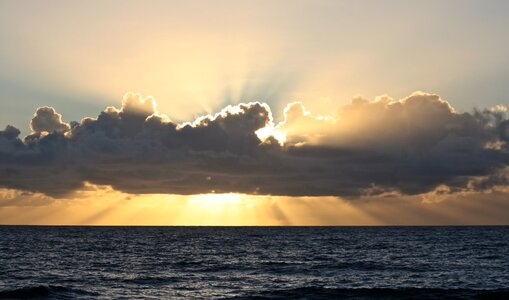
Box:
left=0, top=226, right=509, bottom=299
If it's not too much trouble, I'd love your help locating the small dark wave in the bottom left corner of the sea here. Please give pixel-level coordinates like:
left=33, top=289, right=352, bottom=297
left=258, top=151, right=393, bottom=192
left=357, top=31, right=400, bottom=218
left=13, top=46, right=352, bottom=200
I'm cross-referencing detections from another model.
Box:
left=0, top=285, right=97, bottom=299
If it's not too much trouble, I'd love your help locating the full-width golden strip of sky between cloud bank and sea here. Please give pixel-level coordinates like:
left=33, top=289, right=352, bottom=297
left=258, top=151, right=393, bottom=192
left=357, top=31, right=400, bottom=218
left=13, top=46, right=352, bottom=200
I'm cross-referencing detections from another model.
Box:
left=0, top=185, right=505, bottom=226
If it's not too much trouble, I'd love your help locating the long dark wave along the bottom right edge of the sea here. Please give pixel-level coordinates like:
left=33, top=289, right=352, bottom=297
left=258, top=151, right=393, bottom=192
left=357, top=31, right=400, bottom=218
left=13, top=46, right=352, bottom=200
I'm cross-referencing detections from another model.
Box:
left=227, top=287, right=509, bottom=300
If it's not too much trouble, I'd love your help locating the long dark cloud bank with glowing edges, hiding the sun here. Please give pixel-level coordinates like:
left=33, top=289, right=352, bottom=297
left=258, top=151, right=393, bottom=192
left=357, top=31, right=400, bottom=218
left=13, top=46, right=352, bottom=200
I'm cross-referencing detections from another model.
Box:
left=0, top=92, right=509, bottom=198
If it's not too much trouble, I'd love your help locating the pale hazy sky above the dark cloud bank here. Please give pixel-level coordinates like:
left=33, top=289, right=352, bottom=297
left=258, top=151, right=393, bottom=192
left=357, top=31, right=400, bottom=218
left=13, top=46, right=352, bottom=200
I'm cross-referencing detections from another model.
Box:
left=0, top=0, right=509, bottom=131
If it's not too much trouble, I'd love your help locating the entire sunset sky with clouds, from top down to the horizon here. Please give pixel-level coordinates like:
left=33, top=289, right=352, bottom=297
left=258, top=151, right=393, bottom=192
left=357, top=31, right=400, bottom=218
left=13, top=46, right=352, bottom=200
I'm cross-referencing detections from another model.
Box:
left=0, top=0, right=509, bottom=225
